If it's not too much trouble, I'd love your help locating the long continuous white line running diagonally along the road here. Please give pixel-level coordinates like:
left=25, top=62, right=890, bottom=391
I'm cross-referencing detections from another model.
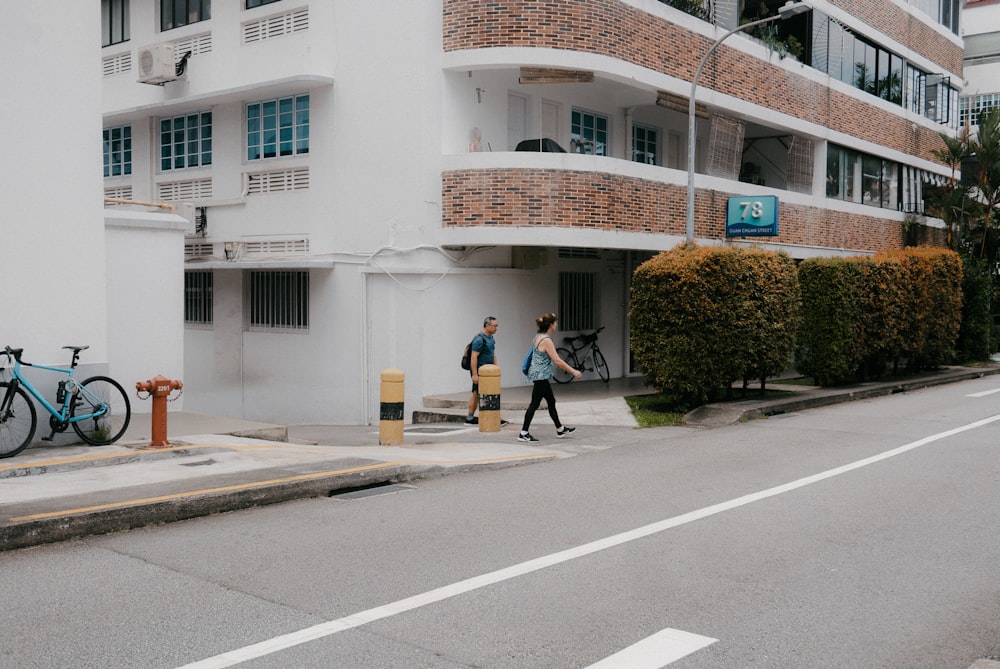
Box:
left=181, top=414, right=1000, bottom=669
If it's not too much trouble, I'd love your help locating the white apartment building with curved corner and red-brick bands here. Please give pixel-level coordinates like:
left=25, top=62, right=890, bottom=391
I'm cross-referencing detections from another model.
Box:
left=99, top=0, right=962, bottom=423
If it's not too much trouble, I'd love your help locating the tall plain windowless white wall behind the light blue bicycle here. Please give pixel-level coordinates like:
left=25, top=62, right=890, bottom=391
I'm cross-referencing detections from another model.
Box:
left=0, top=0, right=108, bottom=366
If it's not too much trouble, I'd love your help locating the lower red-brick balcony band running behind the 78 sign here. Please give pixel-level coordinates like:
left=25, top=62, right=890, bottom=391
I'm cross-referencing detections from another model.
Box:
left=442, top=169, right=940, bottom=251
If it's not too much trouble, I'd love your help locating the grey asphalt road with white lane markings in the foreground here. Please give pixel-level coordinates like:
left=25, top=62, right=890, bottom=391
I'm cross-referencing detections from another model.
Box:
left=0, top=377, right=1000, bottom=669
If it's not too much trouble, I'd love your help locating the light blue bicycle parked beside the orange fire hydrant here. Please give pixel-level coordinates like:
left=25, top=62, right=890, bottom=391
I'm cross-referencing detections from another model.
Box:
left=0, top=346, right=132, bottom=458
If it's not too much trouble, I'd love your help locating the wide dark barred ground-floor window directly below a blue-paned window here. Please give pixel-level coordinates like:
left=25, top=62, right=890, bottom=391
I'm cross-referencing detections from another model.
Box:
left=247, top=271, right=309, bottom=330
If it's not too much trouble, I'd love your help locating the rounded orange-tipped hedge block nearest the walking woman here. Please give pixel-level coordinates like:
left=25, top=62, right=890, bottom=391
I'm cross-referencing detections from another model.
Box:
left=630, top=244, right=800, bottom=403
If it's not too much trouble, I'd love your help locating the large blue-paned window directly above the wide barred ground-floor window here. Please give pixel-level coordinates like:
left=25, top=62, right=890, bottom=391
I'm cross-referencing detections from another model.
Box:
left=247, top=94, right=309, bottom=160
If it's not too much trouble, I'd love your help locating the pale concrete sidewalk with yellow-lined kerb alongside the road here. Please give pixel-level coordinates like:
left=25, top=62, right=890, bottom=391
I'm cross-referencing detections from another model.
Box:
left=0, top=366, right=1000, bottom=550
